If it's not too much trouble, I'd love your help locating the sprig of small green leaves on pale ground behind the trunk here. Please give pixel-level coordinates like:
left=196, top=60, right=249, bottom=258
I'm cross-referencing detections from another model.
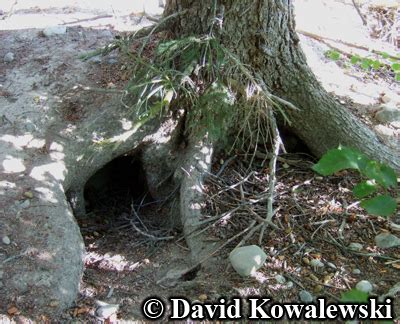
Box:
left=325, top=50, right=400, bottom=82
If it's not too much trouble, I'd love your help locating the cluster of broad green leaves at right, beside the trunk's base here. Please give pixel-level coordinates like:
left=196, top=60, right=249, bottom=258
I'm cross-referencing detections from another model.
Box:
left=312, top=146, right=398, bottom=217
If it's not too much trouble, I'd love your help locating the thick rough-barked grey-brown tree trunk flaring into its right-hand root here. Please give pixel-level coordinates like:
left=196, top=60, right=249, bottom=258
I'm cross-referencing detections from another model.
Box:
left=165, top=0, right=400, bottom=171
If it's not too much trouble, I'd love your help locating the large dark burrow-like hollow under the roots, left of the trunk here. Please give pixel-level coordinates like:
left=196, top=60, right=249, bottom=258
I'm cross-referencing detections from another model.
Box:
left=80, top=152, right=173, bottom=241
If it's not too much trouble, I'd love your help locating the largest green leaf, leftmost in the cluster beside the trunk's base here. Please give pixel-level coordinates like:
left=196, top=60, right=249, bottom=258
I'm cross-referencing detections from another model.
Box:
left=312, top=146, right=368, bottom=176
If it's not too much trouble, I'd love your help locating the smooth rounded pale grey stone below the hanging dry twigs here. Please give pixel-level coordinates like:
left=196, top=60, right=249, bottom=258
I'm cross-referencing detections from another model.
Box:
left=229, top=245, right=267, bottom=277
